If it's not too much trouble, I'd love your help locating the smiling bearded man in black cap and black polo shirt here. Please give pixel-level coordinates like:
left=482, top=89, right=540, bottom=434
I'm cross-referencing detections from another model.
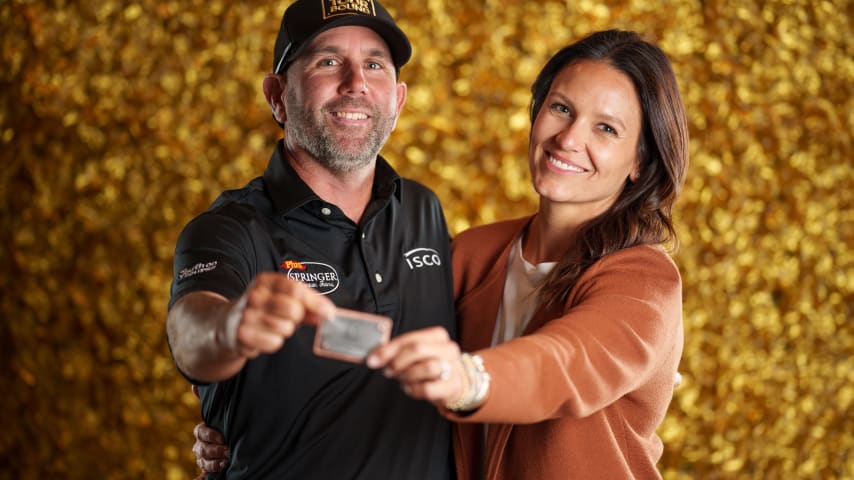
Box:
left=167, top=0, right=455, bottom=479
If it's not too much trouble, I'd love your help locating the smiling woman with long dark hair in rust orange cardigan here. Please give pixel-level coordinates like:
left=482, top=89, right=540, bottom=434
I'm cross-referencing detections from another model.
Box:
left=192, top=30, right=688, bottom=480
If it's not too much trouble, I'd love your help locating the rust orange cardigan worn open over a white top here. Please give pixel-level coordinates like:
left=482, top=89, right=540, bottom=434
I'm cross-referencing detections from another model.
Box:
left=443, top=217, right=683, bottom=480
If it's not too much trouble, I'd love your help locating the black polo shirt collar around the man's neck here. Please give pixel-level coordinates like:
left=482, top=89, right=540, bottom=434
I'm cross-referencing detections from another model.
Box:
left=263, top=140, right=400, bottom=213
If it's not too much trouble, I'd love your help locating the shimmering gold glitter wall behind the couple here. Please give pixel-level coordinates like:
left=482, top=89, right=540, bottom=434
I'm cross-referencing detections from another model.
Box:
left=0, top=0, right=854, bottom=479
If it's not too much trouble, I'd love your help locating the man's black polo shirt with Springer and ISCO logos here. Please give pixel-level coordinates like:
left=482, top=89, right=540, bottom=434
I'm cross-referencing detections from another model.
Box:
left=169, top=141, right=456, bottom=480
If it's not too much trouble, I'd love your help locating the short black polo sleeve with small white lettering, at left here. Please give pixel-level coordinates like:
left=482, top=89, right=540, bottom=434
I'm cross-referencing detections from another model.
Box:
left=169, top=212, right=256, bottom=309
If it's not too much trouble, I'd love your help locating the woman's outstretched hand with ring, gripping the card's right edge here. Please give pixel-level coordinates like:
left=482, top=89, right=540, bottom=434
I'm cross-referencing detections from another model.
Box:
left=367, top=327, right=468, bottom=407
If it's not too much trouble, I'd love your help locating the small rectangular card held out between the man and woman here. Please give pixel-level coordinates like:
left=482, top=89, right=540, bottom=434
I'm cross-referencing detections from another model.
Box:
left=314, top=308, right=392, bottom=363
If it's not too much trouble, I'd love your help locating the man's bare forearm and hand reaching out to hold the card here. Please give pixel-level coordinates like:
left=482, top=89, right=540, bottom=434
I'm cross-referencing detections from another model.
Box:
left=166, top=272, right=335, bottom=382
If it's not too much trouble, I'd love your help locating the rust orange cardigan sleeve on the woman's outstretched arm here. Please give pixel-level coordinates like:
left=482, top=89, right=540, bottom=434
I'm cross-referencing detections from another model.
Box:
left=445, top=246, right=683, bottom=424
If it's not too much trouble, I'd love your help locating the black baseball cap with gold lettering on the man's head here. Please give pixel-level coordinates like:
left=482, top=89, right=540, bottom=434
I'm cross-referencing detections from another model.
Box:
left=273, top=0, right=412, bottom=74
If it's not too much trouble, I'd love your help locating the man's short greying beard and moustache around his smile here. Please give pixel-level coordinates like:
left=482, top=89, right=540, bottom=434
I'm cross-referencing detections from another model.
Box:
left=285, top=88, right=396, bottom=173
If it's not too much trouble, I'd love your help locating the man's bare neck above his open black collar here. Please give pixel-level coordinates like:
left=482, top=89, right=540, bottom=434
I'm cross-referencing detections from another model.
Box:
left=286, top=151, right=376, bottom=224
